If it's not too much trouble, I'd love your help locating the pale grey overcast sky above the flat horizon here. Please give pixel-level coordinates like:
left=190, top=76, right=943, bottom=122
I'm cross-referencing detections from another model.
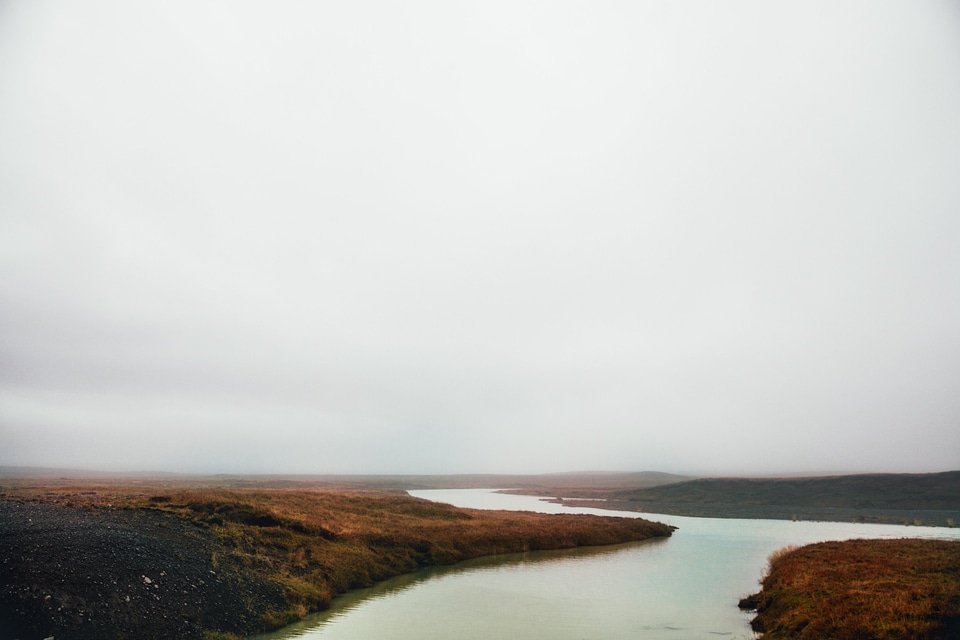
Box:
left=0, top=0, right=960, bottom=475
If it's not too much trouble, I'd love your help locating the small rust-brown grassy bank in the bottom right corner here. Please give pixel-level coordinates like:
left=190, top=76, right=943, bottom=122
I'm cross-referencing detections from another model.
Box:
left=740, top=539, right=960, bottom=640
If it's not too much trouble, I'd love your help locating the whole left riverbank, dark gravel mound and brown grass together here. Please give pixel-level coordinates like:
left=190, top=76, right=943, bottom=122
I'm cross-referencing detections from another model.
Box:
left=0, top=482, right=672, bottom=640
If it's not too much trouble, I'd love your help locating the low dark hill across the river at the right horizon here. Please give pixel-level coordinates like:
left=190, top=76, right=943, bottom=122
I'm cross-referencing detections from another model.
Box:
left=612, top=471, right=960, bottom=511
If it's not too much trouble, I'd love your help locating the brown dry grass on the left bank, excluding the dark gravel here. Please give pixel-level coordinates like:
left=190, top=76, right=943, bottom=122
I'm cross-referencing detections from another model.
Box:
left=0, top=479, right=672, bottom=629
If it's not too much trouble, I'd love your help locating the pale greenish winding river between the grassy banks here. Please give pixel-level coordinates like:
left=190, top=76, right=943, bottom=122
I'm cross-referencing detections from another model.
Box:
left=256, top=489, right=960, bottom=640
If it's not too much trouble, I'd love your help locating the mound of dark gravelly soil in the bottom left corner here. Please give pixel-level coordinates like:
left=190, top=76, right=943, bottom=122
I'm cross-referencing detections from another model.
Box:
left=0, top=499, right=284, bottom=640
